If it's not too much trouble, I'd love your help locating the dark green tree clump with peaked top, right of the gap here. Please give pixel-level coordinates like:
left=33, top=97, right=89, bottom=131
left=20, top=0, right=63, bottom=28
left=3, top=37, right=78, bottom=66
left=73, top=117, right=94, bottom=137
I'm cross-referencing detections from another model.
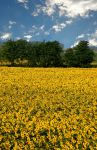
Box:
left=64, top=41, right=94, bottom=67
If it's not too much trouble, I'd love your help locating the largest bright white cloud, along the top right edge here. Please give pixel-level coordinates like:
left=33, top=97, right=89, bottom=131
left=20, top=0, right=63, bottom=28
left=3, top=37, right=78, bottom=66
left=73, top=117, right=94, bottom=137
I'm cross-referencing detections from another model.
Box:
left=33, top=0, right=97, bottom=18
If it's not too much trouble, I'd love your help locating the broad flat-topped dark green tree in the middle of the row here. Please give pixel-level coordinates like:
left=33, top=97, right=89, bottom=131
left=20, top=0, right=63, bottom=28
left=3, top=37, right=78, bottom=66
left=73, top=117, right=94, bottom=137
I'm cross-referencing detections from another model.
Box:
left=28, top=41, right=63, bottom=67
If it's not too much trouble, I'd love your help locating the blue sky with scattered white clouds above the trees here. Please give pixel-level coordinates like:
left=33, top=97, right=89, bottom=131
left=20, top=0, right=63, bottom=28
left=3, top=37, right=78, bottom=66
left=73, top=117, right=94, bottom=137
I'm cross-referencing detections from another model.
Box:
left=0, top=0, right=97, bottom=48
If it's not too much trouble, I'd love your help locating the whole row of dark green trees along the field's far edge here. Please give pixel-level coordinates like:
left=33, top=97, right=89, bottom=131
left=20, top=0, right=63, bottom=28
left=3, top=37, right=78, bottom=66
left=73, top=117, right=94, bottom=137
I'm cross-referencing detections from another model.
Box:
left=0, top=39, right=94, bottom=67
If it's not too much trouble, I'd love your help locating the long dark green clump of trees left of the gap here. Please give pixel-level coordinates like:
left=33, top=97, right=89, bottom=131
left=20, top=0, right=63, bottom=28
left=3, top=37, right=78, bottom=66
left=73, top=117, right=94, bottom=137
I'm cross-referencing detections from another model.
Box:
left=2, top=39, right=63, bottom=67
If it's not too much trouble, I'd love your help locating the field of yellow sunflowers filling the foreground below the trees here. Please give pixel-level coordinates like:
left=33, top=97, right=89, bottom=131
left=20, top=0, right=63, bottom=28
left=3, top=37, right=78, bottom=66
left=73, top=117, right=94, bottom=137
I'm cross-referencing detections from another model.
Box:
left=0, top=67, right=97, bottom=150
